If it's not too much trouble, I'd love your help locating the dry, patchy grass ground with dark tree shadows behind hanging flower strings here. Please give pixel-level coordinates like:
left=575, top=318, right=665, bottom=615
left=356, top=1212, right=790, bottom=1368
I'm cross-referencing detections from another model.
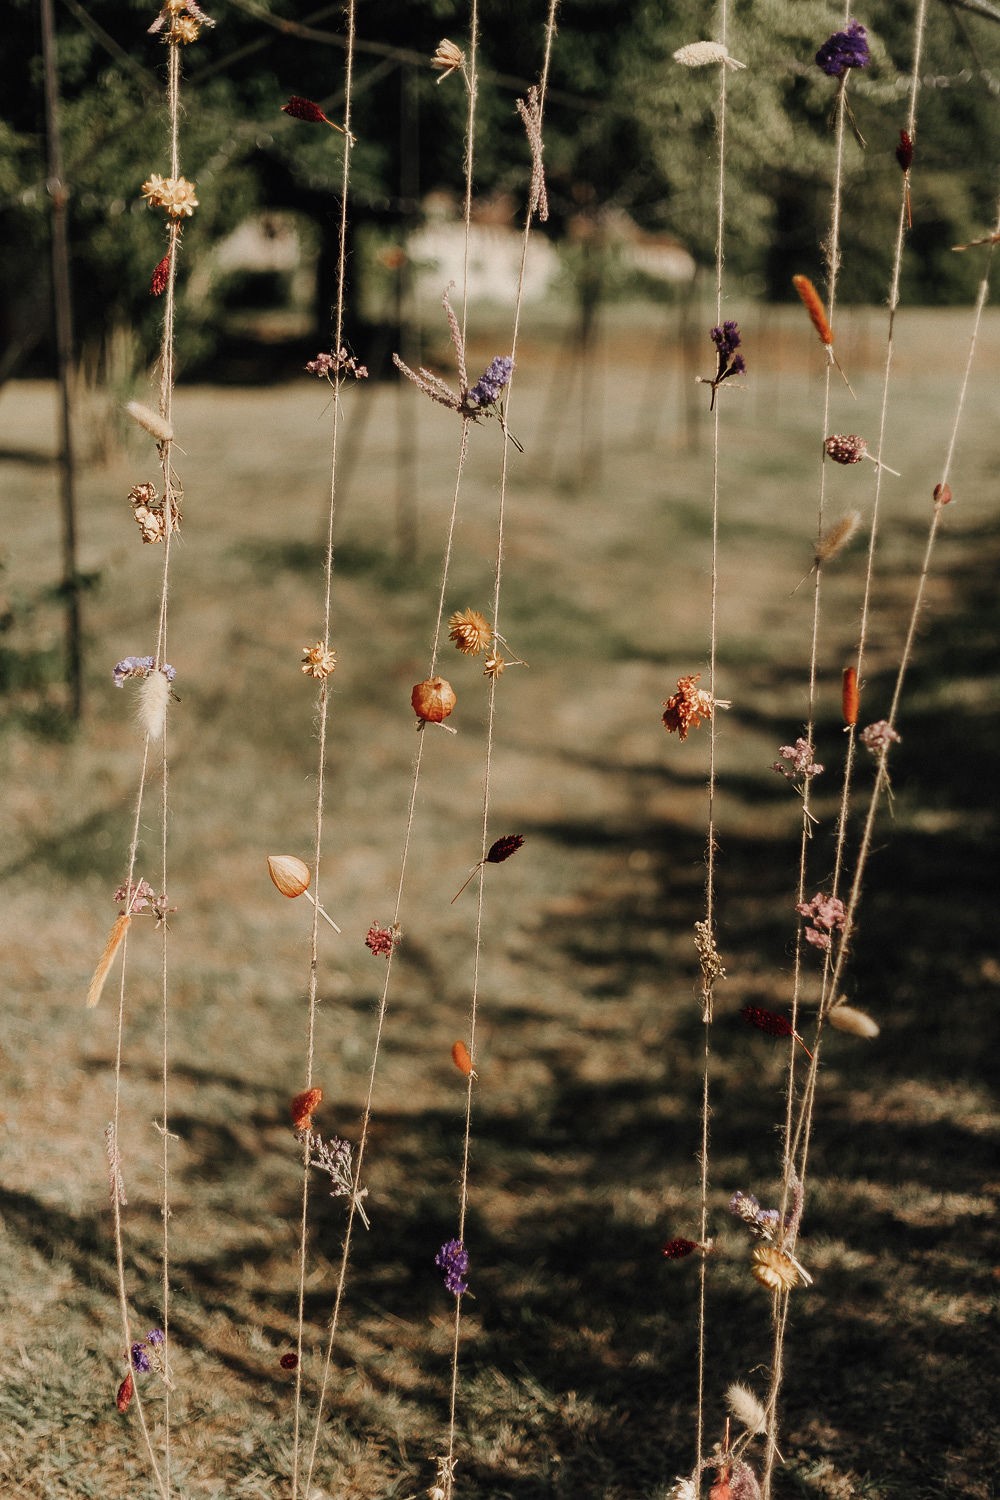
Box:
left=0, top=309, right=1000, bottom=1500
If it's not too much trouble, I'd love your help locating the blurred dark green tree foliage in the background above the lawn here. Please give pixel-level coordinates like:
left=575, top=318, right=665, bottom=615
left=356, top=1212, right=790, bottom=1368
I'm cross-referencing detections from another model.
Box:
left=0, top=0, right=1000, bottom=378
